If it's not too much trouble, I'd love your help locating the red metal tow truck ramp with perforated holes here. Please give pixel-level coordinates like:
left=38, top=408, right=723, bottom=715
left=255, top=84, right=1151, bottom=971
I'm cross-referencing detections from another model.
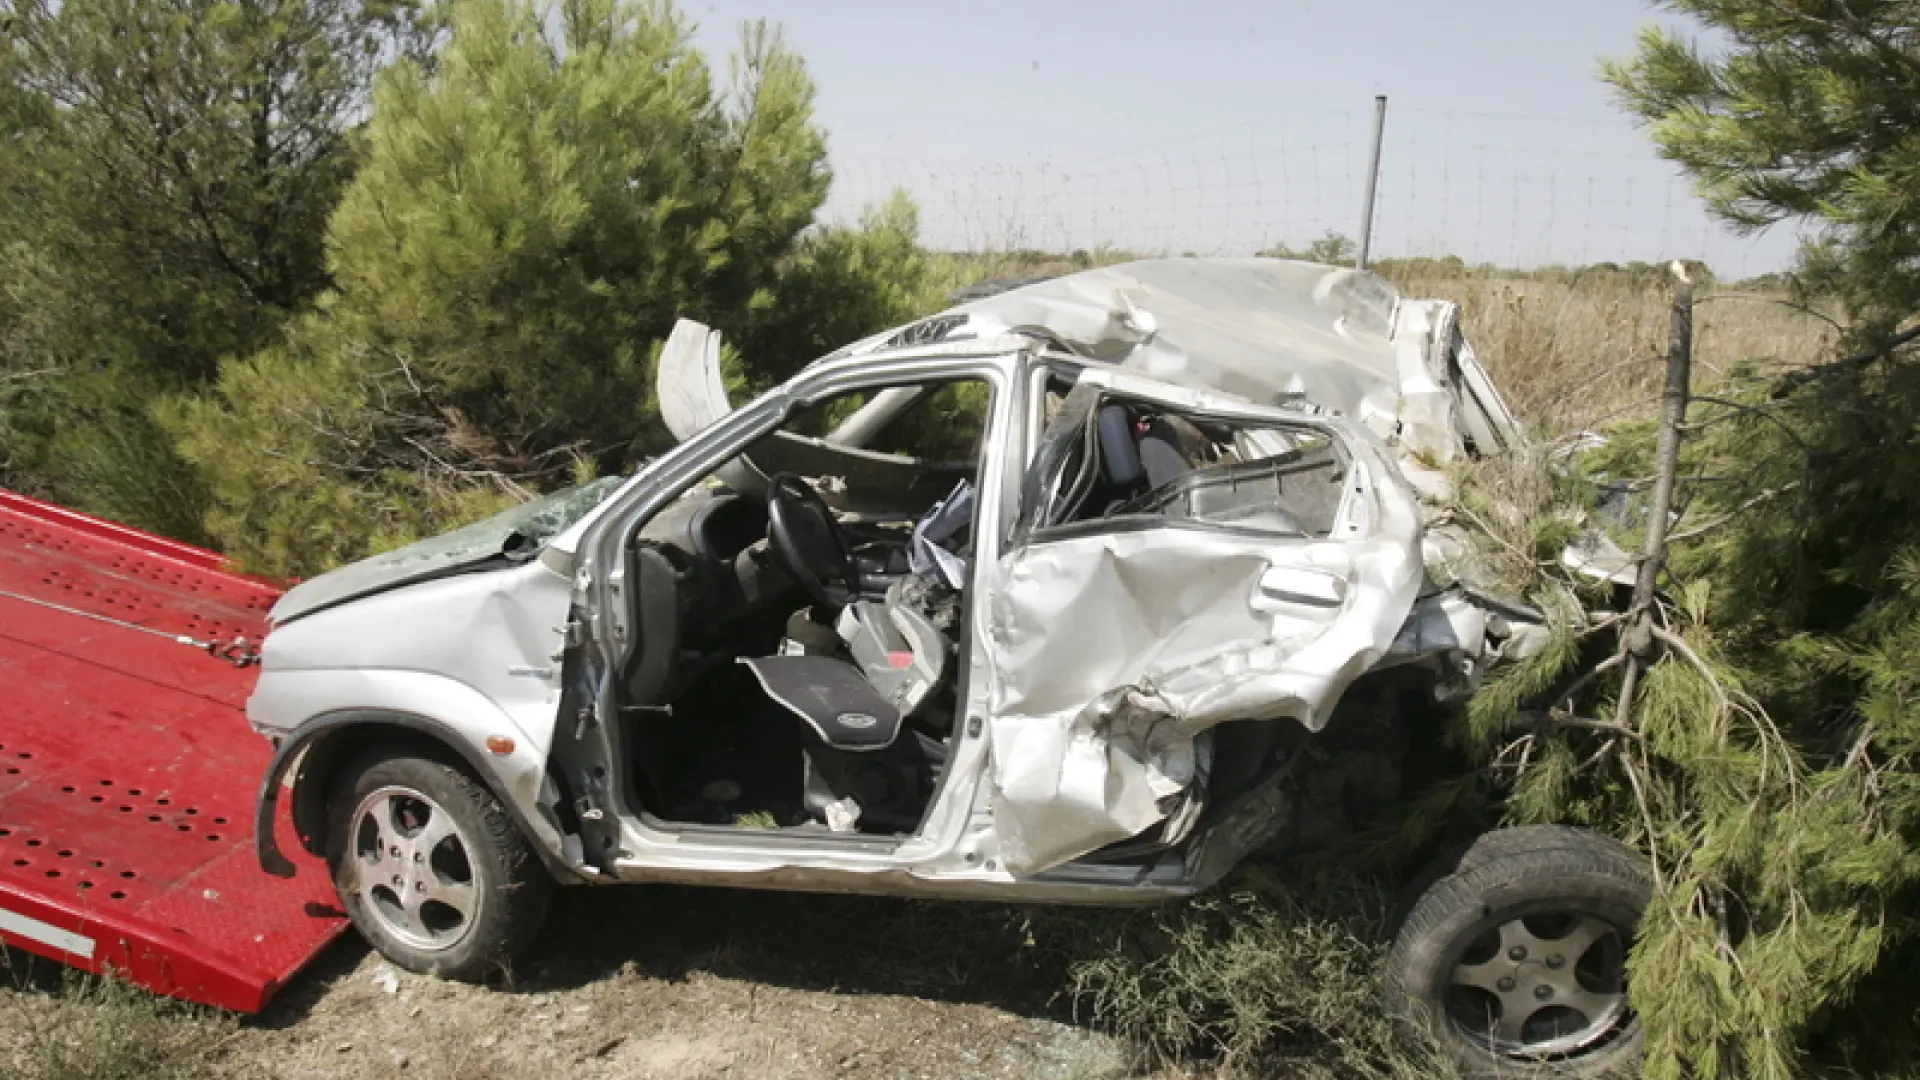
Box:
left=0, top=490, right=346, bottom=1013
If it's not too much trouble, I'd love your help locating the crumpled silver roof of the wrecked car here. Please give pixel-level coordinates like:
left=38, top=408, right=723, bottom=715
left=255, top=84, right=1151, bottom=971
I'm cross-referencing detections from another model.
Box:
left=829, top=258, right=1519, bottom=459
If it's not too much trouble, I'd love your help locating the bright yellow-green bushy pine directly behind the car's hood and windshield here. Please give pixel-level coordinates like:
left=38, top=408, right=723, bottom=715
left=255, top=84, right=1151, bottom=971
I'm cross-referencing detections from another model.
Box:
left=167, top=0, right=922, bottom=571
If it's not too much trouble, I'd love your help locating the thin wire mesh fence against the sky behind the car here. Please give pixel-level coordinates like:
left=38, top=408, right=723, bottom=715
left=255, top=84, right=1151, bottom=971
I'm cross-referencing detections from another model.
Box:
left=828, top=102, right=1797, bottom=279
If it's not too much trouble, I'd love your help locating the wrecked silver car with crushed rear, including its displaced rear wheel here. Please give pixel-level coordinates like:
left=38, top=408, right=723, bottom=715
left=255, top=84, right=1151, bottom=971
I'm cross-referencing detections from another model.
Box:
left=248, top=259, right=1638, bottom=1068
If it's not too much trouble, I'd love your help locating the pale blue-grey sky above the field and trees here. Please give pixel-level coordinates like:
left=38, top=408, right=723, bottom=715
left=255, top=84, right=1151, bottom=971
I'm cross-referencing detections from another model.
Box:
left=684, top=0, right=1793, bottom=275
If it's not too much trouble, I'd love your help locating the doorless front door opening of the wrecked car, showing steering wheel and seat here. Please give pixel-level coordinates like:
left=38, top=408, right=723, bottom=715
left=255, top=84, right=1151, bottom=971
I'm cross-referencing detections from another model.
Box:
left=622, top=380, right=991, bottom=836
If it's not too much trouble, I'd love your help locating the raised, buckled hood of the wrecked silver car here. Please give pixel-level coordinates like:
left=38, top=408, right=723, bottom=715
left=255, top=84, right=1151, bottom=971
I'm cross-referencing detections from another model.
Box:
left=271, top=477, right=626, bottom=625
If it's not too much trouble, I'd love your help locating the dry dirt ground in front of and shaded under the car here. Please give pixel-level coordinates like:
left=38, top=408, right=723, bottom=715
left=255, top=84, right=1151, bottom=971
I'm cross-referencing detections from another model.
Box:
left=0, top=888, right=1185, bottom=1080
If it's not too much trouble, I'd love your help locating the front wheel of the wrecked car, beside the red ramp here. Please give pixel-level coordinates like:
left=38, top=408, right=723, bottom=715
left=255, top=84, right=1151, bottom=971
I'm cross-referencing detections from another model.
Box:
left=326, top=753, right=553, bottom=980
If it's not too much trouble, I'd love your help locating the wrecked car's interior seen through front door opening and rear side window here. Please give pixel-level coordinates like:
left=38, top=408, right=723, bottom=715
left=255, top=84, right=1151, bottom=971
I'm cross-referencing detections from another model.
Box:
left=620, top=368, right=1344, bottom=836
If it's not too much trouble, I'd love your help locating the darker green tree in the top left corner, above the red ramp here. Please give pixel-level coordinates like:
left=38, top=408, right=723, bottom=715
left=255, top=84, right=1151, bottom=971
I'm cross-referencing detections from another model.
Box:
left=0, top=0, right=428, bottom=536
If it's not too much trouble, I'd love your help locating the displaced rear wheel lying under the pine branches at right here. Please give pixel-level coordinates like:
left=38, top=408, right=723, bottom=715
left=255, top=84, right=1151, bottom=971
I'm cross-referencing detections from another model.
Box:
left=1384, top=826, right=1651, bottom=1080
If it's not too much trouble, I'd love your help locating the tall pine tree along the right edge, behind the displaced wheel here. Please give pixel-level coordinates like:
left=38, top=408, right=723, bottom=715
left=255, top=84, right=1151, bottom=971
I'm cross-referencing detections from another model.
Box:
left=1443, top=0, right=1920, bottom=1078
